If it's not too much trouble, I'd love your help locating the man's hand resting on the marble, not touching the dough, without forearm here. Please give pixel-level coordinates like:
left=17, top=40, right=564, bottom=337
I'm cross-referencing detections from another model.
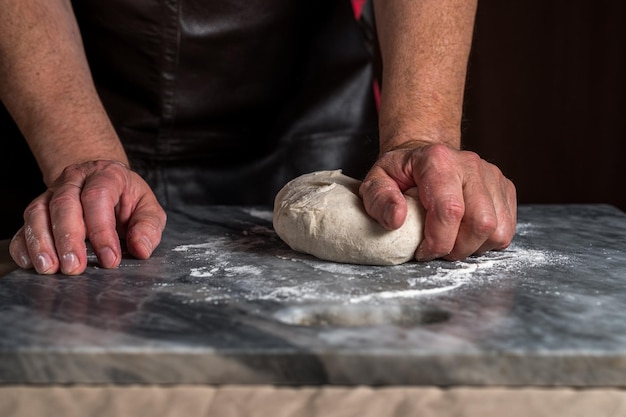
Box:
left=9, top=161, right=166, bottom=275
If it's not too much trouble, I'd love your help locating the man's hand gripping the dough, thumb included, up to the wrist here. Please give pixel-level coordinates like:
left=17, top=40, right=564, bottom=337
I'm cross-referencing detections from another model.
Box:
left=360, top=143, right=517, bottom=261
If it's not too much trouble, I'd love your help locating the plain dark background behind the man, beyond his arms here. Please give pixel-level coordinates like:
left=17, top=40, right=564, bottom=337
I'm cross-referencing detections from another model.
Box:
left=0, top=0, right=626, bottom=238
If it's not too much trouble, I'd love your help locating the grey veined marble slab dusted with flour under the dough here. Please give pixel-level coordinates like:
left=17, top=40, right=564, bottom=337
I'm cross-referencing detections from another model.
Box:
left=0, top=205, right=626, bottom=387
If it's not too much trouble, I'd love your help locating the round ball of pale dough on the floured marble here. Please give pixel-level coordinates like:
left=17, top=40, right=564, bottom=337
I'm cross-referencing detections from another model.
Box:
left=273, top=170, right=424, bottom=265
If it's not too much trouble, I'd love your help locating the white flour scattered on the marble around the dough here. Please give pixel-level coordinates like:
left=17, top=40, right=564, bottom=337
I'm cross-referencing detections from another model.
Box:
left=173, top=221, right=568, bottom=303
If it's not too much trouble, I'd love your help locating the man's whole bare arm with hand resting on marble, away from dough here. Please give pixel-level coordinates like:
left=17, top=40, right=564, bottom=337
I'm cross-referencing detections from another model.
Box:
left=0, top=0, right=165, bottom=274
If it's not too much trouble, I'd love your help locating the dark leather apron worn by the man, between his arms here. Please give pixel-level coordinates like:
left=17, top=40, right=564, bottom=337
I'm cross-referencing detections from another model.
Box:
left=73, top=0, right=377, bottom=207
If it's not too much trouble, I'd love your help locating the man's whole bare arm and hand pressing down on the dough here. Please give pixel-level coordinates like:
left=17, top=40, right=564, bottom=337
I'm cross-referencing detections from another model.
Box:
left=360, top=0, right=517, bottom=260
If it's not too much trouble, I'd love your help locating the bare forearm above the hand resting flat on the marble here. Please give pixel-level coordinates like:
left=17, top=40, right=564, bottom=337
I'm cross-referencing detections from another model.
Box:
left=0, top=0, right=127, bottom=185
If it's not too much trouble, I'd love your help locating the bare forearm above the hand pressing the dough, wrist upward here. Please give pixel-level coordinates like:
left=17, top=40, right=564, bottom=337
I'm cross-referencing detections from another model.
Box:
left=374, top=0, right=477, bottom=152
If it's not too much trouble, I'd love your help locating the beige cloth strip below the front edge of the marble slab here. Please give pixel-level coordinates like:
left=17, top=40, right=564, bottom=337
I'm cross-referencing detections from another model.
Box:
left=0, top=386, right=626, bottom=417
